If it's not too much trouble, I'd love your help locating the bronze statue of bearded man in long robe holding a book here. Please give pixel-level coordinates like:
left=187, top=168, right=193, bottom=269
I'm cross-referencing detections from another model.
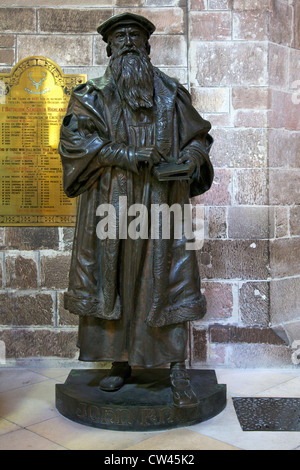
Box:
left=60, top=13, right=213, bottom=407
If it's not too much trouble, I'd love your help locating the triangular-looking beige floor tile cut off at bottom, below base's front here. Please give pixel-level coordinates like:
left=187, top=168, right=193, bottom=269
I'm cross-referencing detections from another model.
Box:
left=126, top=428, right=238, bottom=450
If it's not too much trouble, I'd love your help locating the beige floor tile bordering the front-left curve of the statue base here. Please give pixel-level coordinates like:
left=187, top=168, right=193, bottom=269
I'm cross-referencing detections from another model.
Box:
left=28, top=417, right=162, bottom=450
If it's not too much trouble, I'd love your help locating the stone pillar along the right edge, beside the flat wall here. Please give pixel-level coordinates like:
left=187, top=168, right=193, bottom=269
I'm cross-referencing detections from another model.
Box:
left=269, top=0, right=300, bottom=346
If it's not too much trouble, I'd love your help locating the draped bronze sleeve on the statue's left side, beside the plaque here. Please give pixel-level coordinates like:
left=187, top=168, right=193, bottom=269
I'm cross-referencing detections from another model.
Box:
left=59, top=85, right=138, bottom=197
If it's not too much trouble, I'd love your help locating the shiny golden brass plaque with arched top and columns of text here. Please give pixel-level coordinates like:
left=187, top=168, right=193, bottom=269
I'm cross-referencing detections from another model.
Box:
left=0, top=57, right=87, bottom=226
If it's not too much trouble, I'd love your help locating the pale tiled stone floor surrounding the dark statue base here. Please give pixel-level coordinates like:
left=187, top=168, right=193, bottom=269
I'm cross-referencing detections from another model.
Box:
left=0, top=368, right=300, bottom=450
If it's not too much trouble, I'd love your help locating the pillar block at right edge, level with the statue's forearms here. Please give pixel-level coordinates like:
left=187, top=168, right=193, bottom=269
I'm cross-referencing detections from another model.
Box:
left=269, top=129, right=300, bottom=169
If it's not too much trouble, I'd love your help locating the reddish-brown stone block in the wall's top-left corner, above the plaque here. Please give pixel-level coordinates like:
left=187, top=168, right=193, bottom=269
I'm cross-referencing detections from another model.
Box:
left=0, top=8, right=36, bottom=33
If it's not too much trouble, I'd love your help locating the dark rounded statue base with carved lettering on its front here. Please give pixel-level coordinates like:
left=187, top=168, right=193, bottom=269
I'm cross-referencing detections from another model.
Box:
left=56, top=369, right=226, bottom=431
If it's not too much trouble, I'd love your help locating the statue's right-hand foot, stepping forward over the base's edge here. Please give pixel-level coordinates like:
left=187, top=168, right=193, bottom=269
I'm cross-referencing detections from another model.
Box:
left=170, top=365, right=199, bottom=408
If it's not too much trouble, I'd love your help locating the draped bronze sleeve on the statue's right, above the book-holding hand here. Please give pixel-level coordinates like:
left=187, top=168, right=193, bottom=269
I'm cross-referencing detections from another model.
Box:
left=176, top=85, right=214, bottom=197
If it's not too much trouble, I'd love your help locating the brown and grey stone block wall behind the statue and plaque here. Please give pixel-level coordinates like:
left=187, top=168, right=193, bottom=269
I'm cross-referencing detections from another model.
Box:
left=0, top=0, right=300, bottom=367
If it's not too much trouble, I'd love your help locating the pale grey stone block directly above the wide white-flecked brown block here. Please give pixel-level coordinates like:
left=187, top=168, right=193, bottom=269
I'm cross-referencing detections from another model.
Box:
left=228, top=206, right=269, bottom=240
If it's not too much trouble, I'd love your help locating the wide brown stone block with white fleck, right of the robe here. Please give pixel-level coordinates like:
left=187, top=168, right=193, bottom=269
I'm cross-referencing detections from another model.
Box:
left=197, top=240, right=269, bottom=280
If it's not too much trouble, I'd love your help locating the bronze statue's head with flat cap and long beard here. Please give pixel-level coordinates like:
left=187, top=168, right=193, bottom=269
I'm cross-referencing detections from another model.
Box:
left=97, top=13, right=155, bottom=110
